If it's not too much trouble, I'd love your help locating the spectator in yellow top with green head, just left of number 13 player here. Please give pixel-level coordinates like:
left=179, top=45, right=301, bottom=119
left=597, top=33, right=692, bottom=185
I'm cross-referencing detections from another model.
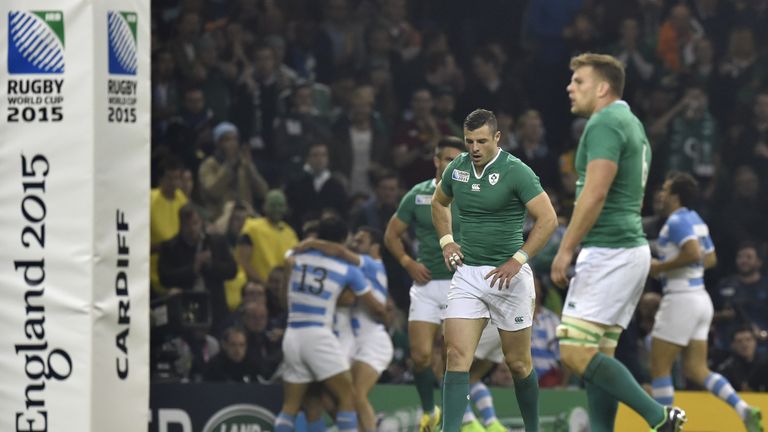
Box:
left=237, top=189, right=299, bottom=281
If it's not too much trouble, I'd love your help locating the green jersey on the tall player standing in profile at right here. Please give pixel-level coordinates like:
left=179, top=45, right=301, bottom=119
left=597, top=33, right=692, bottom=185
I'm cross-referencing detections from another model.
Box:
left=575, top=101, right=651, bottom=248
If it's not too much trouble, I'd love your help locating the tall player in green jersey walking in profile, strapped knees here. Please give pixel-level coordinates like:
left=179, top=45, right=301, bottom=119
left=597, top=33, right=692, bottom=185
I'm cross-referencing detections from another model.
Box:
left=551, top=53, right=686, bottom=432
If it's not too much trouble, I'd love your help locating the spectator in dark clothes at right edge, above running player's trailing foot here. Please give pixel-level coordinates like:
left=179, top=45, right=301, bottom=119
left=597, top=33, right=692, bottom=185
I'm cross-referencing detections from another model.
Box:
left=715, top=325, right=768, bottom=391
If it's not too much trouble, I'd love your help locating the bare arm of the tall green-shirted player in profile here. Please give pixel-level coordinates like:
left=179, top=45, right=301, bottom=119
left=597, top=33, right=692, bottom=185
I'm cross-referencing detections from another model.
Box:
left=560, top=159, right=619, bottom=251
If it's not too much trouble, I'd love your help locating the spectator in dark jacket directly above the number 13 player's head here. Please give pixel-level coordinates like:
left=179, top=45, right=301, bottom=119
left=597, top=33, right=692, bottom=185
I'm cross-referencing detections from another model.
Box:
left=285, top=141, right=347, bottom=231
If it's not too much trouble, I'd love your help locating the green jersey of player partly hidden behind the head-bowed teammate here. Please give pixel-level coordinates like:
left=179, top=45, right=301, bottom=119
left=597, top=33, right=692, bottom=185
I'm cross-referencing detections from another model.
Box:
left=395, top=179, right=461, bottom=280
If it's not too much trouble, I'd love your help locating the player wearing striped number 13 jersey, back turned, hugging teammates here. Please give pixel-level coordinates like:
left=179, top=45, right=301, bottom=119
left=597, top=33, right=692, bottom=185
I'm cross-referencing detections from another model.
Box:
left=275, top=218, right=385, bottom=432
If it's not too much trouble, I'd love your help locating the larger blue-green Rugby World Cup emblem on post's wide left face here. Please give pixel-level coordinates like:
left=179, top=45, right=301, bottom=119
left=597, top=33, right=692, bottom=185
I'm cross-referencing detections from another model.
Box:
left=8, top=11, right=64, bottom=74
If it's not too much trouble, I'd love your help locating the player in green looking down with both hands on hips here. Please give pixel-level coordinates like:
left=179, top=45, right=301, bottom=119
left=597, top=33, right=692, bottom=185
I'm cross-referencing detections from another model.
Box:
left=432, top=109, right=557, bottom=432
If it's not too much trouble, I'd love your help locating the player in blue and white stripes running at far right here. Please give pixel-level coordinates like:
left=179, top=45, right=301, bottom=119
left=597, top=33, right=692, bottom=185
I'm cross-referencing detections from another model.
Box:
left=651, top=173, right=763, bottom=432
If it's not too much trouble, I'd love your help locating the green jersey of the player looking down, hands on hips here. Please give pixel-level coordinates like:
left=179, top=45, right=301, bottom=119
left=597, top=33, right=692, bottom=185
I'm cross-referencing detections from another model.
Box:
left=440, top=150, right=543, bottom=266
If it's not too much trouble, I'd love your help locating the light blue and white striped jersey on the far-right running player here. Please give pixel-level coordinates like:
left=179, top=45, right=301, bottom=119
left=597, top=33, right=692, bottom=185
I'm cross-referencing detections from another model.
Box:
left=658, top=207, right=715, bottom=293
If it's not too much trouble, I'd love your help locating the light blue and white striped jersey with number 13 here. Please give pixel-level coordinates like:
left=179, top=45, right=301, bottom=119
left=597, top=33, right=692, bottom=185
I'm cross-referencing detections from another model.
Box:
left=288, top=250, right=371, bottom=328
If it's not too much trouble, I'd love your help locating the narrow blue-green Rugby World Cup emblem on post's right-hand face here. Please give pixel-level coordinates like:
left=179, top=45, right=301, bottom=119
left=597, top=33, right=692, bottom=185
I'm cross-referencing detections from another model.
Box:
left=107, top=11, right=137, bottom=75
